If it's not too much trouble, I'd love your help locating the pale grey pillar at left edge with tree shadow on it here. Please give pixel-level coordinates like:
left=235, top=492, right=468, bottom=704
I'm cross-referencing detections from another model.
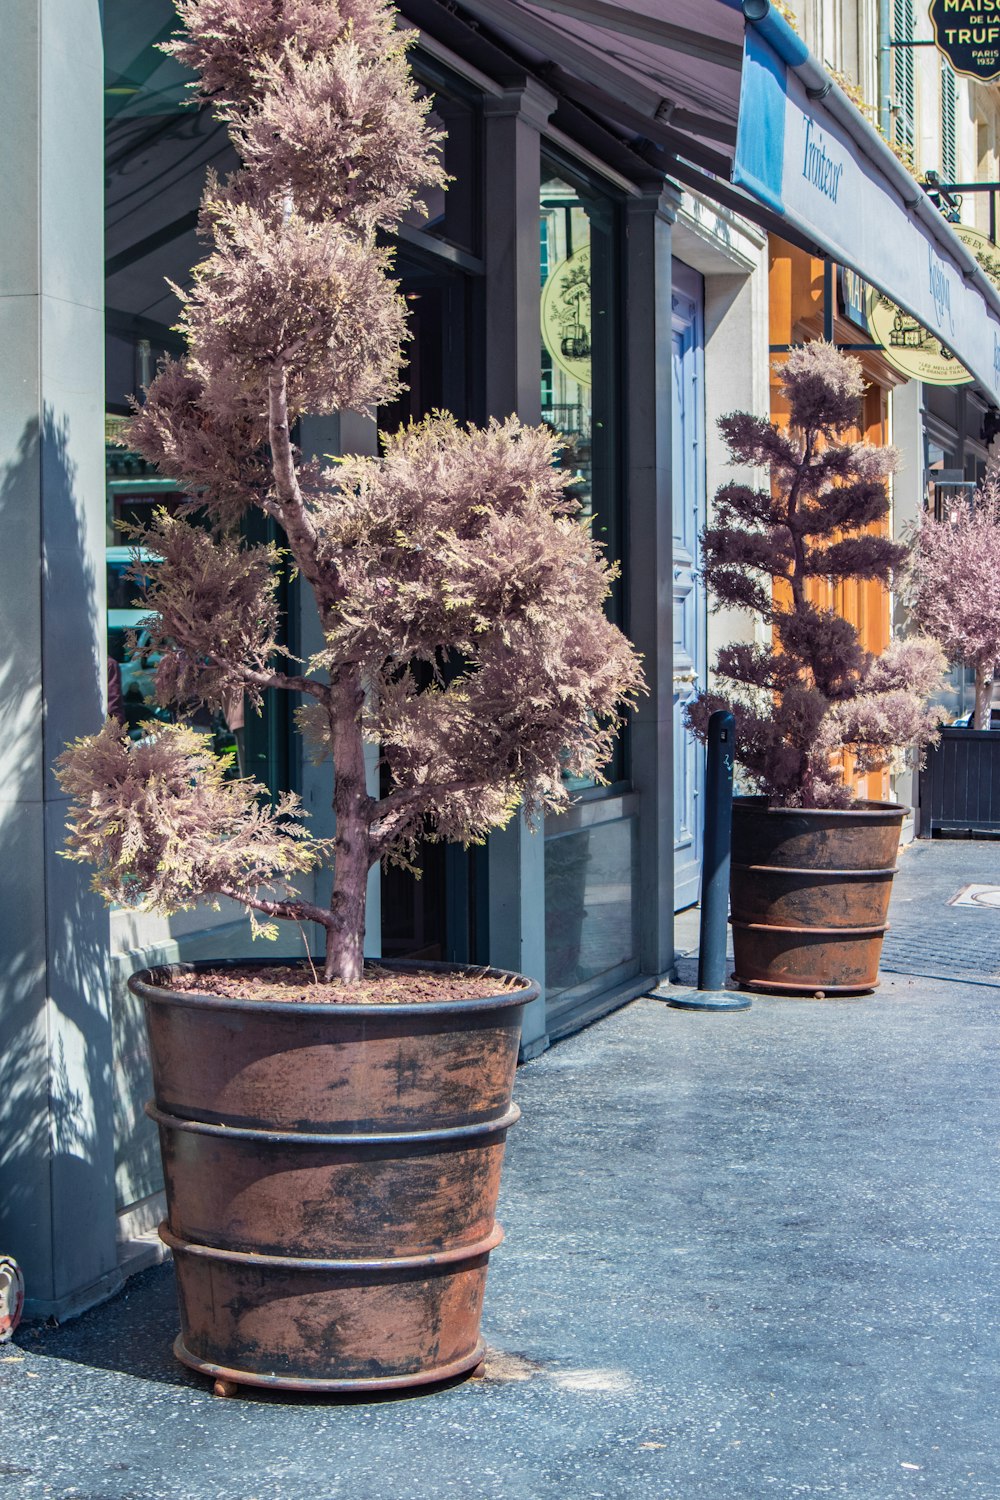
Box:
left=0, top=0, right=120, bottom=1317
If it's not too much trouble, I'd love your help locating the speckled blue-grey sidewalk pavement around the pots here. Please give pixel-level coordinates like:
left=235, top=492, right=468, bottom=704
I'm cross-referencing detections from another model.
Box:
left=0, top=843, right=1000, bottom=1500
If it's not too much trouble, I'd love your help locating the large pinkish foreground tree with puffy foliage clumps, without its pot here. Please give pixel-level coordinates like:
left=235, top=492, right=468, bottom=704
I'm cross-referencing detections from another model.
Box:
left=58, top=0, right=640, bottom=983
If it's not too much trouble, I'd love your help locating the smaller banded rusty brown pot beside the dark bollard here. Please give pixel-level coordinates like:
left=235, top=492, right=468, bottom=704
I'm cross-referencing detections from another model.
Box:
left=730, top=797, right=907, bottom=995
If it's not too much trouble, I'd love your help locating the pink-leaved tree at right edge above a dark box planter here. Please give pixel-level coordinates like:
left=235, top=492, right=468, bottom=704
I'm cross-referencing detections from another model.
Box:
left=907, top=468, right=1000, bottom=729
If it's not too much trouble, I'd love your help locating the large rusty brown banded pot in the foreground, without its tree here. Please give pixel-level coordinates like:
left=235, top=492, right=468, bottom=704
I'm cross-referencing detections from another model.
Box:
left=129, top=963, right=538, bottom=1392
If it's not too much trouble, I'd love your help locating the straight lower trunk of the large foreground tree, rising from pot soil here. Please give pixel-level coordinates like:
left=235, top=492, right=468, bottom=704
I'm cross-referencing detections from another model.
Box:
left=324, top=671, right=372, bottom=984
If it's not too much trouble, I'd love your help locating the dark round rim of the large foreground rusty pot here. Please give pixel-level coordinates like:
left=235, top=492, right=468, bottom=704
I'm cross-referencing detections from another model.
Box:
left=129, top=959, right=541, bottom=1019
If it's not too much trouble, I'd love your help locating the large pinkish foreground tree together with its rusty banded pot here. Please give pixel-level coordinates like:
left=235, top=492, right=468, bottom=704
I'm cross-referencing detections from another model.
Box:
left=58, top=0, right=640, bottom=1392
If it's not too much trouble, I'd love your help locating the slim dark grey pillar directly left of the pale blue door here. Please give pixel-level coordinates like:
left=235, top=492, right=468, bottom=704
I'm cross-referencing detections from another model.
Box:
left=625, top=183, right=679, bottom=977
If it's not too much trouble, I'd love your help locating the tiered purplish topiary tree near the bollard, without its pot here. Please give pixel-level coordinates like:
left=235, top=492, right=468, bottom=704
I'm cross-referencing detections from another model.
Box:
left=688, top=342, right=943, bottom=807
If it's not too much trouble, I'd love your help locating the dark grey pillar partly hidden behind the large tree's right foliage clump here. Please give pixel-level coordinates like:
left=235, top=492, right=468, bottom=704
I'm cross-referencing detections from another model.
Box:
left=486, top=80, right=556, bottom=1058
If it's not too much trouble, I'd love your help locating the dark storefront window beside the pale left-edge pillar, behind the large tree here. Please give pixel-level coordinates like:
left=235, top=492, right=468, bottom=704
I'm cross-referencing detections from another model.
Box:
left=105, top=0, right=289, bottom=792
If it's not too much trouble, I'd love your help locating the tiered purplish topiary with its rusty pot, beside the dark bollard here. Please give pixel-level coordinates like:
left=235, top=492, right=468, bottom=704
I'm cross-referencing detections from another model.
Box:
left=688, top=342, right=943, bottom=995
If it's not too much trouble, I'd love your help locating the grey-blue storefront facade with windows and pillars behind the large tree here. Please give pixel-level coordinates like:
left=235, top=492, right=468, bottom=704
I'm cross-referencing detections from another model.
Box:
left=0, top=0, right=1000, bottom=1317
